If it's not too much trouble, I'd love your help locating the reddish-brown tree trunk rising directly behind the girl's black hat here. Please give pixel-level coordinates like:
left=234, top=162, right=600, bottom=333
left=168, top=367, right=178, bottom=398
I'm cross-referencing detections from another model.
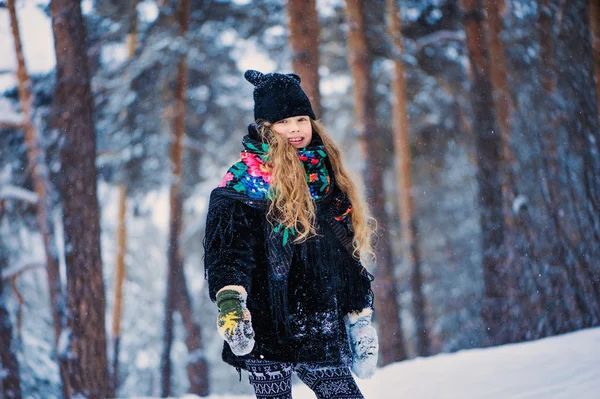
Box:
left=287, top=0, right=323, bottom=118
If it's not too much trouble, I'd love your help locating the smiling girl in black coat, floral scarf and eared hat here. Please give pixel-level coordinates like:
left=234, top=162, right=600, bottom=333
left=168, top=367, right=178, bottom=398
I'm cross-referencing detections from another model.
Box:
left=204, top=71, right=378, bottom=398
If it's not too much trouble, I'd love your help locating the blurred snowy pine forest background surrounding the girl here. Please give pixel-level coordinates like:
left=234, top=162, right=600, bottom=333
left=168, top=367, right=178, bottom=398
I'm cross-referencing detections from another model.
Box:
left=0, top=0, right=600, bottom=399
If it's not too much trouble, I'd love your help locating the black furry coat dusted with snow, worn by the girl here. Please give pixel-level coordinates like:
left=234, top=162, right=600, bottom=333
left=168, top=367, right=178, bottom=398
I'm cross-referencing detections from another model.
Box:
left=204, top=175, right=373, bottom=368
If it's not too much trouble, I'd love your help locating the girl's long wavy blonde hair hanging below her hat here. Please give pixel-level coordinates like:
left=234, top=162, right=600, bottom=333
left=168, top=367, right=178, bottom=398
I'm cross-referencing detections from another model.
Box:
left=256, top=119, right=374, bottom=259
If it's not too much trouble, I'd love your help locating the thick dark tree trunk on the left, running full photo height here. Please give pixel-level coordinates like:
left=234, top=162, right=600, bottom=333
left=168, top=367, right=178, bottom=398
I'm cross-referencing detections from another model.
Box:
left=51, top=0, right=109, bottom=399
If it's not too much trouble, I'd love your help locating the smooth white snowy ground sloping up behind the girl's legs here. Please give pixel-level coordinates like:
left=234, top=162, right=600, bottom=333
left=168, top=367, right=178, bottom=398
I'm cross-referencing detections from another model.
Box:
left=141, top=328, right=600, bottom=399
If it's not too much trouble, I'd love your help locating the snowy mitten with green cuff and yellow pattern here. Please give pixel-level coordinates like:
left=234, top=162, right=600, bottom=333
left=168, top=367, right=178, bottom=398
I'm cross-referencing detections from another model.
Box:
left=217, top=285, right=254, bottom=356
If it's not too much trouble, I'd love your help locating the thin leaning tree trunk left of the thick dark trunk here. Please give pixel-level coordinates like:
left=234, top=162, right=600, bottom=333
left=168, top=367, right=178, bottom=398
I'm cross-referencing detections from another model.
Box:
left=8, top=0, right=64, bottom=360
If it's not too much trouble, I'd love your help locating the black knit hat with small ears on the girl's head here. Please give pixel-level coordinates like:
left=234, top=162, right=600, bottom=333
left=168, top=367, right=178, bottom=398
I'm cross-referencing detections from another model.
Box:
left=244, top=69, right=317, bottom=122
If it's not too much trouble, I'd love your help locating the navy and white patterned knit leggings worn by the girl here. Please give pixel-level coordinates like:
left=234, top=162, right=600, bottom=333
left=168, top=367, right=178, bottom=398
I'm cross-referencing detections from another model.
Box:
left=246, top=359, right=364, bottom=399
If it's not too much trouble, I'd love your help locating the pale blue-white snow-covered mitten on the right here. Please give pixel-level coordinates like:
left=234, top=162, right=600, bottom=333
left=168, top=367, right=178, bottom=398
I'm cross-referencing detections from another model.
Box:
left=346, top=308, right=379, bottom=378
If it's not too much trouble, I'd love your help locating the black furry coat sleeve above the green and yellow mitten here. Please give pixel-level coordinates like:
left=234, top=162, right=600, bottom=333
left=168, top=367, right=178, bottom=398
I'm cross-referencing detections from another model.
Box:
left=204, top=198, right=262, bottom=301
